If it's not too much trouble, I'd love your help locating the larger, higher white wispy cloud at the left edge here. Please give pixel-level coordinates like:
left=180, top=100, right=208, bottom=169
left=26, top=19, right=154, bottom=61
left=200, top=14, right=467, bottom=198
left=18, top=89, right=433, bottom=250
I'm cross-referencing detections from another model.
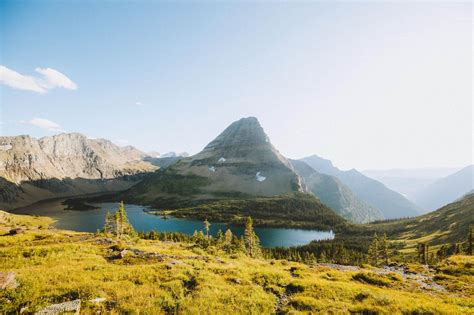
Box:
left=0, top=65, right=77, bottom=93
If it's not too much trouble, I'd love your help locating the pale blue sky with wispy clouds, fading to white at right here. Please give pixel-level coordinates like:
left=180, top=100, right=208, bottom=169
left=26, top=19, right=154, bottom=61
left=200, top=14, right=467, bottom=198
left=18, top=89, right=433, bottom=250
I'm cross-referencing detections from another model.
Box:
left=0, top=1, right=474, bottom=169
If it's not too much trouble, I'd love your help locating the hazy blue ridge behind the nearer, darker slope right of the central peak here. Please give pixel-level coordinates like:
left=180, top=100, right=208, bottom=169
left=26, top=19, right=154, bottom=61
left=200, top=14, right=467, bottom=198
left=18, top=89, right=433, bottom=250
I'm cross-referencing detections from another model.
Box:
left=302, top=155, right=419, bottom=219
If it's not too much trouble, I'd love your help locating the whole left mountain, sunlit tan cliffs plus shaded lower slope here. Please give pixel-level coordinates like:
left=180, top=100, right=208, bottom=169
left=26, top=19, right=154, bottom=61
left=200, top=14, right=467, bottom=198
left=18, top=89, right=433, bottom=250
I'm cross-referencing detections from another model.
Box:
left=0, top=133, right=156, bottom=209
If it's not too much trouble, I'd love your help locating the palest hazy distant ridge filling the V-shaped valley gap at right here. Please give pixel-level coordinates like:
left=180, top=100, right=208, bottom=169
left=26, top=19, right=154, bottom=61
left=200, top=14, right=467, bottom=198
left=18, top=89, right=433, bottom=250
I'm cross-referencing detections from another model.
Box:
left=362, top=167, right=459, bottom=203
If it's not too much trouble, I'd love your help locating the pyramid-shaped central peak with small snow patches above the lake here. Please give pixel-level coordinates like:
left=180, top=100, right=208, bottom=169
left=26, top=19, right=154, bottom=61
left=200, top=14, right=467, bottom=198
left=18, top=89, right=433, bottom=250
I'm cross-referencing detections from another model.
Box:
left=127, top=117, right=304, bottom=208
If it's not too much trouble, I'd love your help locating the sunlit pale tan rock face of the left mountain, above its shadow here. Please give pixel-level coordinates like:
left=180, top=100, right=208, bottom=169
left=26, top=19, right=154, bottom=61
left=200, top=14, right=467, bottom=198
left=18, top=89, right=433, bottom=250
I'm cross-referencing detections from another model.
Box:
left=0, top=133, right=152, bottom=184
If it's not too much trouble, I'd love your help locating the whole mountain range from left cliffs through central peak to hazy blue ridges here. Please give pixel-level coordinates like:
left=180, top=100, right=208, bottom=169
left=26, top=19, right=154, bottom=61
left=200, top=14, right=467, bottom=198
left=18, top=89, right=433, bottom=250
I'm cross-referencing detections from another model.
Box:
left=0, top=117, right=466, bottom=223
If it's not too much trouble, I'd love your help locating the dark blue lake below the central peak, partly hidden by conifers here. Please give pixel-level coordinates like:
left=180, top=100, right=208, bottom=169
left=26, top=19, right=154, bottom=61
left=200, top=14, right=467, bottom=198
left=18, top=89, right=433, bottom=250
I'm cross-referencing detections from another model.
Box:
left=15, top=200, right=334, bottom=247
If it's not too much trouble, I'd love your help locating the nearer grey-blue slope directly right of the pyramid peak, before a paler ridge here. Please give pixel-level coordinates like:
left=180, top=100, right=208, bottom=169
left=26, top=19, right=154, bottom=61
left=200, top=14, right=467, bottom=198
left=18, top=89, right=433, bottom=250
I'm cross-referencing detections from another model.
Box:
left=290, top=160, right=383, bottom=223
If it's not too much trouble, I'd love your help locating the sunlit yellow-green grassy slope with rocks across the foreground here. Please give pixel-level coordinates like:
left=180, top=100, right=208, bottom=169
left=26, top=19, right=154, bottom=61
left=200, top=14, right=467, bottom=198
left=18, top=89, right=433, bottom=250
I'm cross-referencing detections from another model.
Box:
left=0, top=212, right=474, bottom=314
